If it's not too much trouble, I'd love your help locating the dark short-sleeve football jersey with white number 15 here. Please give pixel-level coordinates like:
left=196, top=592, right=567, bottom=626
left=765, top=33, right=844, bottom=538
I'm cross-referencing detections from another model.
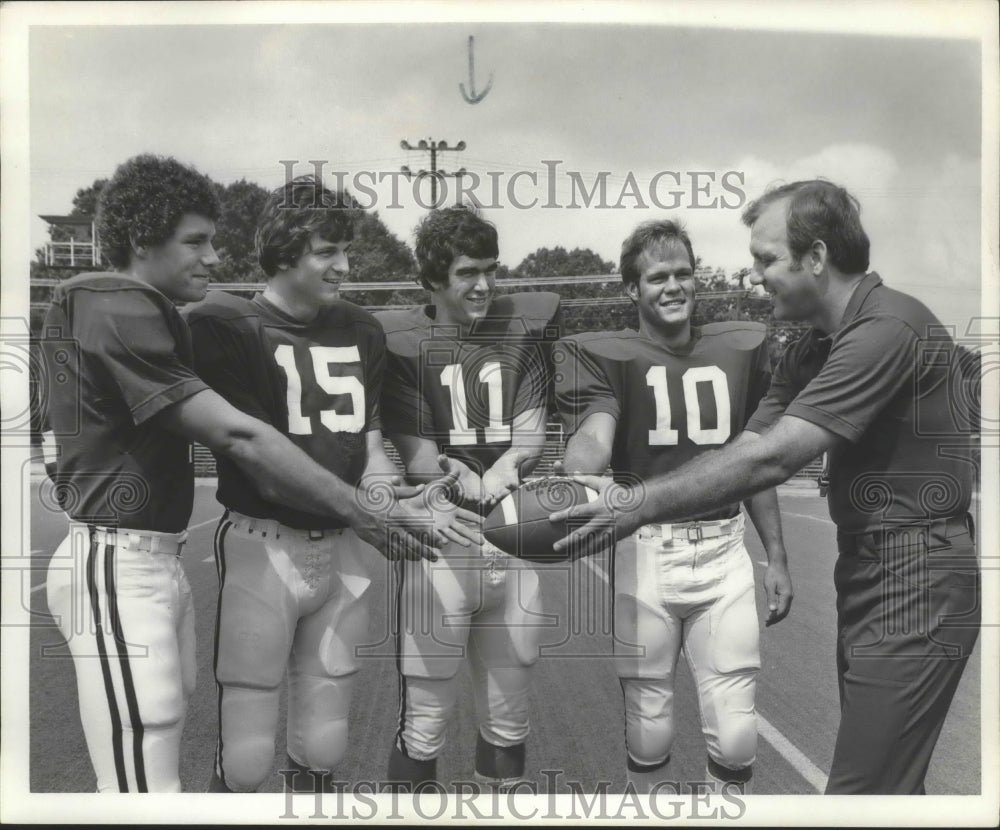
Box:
left=185, top=291, right=385, bottom=530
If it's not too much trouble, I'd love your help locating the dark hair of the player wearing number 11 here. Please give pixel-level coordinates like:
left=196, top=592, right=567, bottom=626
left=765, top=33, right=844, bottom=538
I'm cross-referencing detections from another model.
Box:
left=414, top=205, right=500, bottom=291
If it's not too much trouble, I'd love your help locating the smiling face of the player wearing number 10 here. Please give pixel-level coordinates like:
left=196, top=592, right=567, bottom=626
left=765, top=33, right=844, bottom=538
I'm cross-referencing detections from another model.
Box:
left=626, top=240, right=695, bottom=341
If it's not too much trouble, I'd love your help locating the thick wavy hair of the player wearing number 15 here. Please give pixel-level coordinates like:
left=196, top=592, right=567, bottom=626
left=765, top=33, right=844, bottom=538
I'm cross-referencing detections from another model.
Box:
left=254, top=174, right=358, bottom=277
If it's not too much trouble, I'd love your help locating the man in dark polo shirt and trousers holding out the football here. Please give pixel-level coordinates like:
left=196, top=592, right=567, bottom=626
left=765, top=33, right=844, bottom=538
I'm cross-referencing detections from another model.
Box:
left=556, top=181, right=980, bottom=794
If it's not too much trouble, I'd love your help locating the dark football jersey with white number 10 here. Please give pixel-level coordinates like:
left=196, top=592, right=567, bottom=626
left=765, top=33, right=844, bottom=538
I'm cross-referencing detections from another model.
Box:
left=553, top=322, right=770, bottom=518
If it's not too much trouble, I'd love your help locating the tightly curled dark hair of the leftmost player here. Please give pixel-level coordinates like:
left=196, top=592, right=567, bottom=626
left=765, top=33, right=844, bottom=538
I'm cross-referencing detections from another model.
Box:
left=97, top=153, right=222, bottom=268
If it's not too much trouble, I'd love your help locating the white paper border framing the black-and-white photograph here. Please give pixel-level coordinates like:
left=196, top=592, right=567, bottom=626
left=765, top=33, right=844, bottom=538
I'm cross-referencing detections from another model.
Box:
left=0, top=0, right=1000, bottom=827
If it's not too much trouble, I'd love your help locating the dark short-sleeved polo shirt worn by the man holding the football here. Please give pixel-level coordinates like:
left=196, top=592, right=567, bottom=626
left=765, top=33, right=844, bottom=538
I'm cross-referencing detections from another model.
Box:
left=747, top=273, right=974, bottom=533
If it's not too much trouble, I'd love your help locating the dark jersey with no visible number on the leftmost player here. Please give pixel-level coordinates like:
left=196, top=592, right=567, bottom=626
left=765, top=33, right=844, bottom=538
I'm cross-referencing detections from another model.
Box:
left=42, top=273, right=206, bottom=533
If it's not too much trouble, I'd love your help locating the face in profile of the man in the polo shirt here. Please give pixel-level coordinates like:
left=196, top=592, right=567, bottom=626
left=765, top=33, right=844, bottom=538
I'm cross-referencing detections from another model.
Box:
left=750, top=199, right=820, bottom=320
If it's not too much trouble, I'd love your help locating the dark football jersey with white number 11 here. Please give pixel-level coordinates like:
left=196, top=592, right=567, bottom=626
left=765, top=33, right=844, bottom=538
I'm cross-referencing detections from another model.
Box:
left=377, top=292, right=559, bottom=475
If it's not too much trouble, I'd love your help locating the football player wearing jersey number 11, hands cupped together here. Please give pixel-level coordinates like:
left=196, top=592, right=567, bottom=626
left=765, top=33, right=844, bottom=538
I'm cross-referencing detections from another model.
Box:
left=379, top=207, right=559, bottom=787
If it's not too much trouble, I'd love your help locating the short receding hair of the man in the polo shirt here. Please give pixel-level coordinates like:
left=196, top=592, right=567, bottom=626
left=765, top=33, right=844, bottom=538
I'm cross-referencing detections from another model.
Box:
left=742, top=179, right=871, bottom=274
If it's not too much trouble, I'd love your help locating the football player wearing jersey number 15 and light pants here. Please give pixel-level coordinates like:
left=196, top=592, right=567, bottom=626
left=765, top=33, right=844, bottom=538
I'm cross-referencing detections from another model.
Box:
left=187, top=176, right=479, bottom=792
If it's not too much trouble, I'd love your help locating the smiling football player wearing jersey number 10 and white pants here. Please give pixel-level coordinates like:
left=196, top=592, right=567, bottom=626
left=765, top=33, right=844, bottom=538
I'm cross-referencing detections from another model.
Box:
left=553, top=221, right=792, bottom=793
